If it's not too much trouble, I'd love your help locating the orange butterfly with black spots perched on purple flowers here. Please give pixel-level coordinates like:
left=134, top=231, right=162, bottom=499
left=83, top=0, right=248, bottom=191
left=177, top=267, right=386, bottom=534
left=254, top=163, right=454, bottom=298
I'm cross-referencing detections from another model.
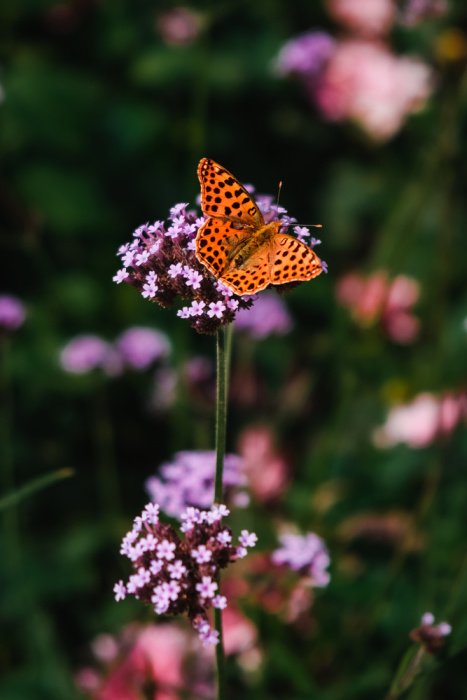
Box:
left=195, top=158, right=322, bottom=295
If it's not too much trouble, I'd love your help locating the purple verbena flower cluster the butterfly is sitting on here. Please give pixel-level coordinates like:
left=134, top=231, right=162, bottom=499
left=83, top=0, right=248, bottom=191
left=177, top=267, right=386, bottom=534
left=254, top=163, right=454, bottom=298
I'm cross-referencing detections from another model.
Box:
left=113, top=196, right=326, bottom=334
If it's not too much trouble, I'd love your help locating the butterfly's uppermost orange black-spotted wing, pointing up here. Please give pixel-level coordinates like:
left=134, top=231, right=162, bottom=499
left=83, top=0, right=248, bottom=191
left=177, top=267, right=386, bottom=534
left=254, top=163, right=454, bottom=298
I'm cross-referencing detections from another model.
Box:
left=198, top=158, right=264, bottom=229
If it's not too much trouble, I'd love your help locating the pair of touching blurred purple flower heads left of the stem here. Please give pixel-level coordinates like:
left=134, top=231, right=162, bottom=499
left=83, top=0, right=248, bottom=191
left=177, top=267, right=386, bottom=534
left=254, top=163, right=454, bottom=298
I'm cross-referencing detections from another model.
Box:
left=60, top=326, right=170, bottom=377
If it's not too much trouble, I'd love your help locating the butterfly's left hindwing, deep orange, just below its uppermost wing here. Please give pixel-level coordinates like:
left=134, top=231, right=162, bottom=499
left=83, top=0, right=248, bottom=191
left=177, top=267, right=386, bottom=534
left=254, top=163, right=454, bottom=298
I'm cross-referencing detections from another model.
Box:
left=196, top=216, right=251, bottom=278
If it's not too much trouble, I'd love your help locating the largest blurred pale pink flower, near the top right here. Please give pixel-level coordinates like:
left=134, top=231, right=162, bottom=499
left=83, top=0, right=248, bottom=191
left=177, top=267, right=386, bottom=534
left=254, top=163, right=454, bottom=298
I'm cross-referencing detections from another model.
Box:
left=316, top=39, right=432, bottom=141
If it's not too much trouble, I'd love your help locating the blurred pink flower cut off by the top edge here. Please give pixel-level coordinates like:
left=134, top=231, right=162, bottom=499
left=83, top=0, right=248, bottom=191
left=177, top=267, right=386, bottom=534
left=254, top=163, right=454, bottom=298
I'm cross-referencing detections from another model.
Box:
left=327, top=0, right=396, bottom=36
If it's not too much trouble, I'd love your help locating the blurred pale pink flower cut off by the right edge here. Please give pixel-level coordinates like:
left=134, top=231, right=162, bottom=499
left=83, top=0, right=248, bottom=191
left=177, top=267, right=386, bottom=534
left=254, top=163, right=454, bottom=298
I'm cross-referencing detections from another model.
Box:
left=373, top=392, right=467, bottom=449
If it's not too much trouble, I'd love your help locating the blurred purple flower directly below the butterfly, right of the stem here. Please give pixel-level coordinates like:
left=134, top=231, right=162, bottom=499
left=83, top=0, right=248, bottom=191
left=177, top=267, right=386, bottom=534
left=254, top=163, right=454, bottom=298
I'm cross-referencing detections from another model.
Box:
left=235, top=292, right=292, bottom=340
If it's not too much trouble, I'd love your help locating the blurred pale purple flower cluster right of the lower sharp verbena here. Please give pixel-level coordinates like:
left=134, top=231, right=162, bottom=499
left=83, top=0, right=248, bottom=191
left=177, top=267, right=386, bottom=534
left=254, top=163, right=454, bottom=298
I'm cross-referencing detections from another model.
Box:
left=271, top=532, right=330, bottom=587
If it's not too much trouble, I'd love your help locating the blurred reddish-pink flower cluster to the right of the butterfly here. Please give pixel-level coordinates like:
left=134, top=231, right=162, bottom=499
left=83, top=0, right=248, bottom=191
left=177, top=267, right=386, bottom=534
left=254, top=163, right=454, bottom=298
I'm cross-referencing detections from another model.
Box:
left=336, top=271, right=420, bottom=345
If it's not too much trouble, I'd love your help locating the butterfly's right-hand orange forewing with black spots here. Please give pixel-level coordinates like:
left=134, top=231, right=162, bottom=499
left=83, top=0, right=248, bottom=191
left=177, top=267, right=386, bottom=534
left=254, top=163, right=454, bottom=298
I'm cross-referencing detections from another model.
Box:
left=269, top=233, right=323, bottom=284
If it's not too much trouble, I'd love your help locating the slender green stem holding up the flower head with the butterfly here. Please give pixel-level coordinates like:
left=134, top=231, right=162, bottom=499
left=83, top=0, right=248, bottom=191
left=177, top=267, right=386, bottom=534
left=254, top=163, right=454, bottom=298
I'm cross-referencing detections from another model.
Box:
left=214, top=327, right=231, bottom=700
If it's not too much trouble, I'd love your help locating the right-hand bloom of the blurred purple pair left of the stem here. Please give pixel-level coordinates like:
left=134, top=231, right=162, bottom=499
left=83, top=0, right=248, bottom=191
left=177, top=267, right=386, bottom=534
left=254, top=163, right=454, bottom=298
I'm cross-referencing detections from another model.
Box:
left=116, top=326, right=170, bottom=370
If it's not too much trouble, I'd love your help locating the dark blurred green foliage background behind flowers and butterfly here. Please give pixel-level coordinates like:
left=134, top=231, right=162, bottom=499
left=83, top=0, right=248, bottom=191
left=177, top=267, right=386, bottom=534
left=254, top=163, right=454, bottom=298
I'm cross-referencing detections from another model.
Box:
left=0, top=0, right=467, bottom=700
